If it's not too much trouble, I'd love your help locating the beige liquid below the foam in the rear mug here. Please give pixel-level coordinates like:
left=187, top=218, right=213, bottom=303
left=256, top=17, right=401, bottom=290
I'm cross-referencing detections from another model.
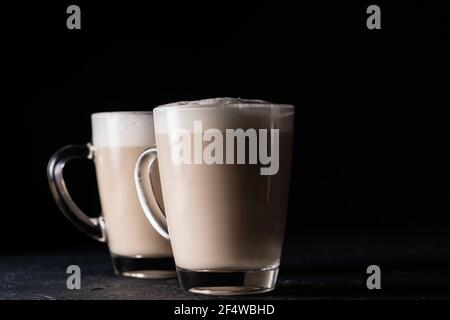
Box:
left=95, top=147, right=172, bottom=257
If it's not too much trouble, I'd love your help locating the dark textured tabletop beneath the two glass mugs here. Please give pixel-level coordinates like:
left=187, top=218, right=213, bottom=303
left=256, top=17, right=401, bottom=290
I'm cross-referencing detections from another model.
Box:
left=0, top=231, right=450, bottom=300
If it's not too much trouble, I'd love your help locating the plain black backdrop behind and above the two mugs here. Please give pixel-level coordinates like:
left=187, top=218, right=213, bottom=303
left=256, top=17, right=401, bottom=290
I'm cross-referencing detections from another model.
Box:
left=14, top=1, right=450, bottom=259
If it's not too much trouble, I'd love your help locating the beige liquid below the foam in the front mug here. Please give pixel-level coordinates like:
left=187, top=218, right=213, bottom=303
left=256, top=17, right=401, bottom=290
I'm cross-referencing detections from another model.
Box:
left=157, top=132, right=292, bottom=270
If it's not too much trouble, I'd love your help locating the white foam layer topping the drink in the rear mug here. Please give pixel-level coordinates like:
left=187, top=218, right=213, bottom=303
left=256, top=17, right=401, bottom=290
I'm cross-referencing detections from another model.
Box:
left=91, top=112, right=155, bottom=148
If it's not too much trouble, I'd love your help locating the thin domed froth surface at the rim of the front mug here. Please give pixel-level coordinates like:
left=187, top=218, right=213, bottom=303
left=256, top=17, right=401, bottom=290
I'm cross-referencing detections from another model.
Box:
left=154, top=98, right=294, bottom=112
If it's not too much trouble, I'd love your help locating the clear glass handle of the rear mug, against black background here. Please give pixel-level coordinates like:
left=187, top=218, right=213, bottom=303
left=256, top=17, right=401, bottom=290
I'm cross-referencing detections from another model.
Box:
left=47, top=143, right=106, bottom=242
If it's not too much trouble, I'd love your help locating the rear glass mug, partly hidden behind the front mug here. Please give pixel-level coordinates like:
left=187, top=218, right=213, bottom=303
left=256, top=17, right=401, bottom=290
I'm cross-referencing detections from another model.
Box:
left=47, top=112, right=176, bottom=278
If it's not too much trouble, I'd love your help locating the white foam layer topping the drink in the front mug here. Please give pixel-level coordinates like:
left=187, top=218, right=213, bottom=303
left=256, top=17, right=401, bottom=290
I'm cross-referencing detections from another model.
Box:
left=154, top=98, right=294, bottom=134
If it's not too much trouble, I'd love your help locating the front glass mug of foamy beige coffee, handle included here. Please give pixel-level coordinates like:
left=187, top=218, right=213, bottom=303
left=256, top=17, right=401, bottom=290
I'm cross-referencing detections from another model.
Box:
left=135, top=98, right=294, bottom=295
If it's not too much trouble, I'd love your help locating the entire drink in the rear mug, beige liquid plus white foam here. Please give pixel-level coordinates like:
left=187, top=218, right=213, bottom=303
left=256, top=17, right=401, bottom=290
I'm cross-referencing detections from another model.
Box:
left=92, top=113, right=172, bottom=257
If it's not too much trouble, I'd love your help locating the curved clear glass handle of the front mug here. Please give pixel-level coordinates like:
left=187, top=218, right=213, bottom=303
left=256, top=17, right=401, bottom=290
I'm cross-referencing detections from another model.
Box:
left=134, top=146, right=169, bottom=240
